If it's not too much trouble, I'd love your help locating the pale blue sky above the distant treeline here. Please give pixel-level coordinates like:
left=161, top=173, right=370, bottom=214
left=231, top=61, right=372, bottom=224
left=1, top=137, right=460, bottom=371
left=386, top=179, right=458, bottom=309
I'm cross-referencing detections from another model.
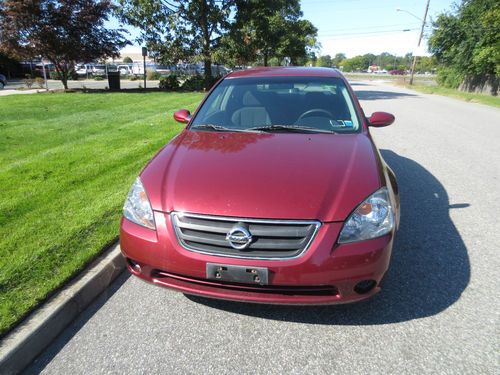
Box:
left=116, top=0, right=455, bottom=57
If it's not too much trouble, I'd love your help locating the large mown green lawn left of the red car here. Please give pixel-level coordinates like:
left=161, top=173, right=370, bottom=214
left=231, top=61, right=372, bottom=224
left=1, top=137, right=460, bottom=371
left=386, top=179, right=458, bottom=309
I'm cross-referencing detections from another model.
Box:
left=0, top=92, right=203, bottom=335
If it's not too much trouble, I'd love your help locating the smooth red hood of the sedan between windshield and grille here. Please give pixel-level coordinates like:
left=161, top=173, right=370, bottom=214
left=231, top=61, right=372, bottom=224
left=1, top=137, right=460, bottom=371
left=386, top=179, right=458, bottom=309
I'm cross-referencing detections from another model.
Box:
left=141, top=130, right=381, bottom=222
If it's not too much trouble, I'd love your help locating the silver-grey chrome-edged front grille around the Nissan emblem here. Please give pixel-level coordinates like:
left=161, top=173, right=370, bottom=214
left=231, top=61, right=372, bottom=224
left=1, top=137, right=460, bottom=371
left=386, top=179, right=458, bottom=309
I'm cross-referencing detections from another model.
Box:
left=172, top=213, right=321, bottom=259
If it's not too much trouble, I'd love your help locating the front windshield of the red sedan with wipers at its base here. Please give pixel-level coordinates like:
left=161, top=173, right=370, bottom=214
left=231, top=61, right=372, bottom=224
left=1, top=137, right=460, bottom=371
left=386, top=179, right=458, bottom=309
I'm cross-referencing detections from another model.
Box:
left=190, top=77, right=360, bottom=133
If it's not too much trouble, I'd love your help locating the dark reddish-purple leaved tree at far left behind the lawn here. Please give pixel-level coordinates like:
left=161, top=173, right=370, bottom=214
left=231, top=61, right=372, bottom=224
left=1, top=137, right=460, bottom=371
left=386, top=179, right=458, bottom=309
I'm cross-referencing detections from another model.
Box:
left=0, top=0, right=128, bottom=89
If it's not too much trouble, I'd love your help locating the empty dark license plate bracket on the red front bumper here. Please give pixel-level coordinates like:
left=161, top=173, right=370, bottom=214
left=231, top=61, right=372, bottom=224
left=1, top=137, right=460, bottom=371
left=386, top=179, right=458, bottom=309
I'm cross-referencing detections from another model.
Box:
left=207, top=263, right=269, bottom=285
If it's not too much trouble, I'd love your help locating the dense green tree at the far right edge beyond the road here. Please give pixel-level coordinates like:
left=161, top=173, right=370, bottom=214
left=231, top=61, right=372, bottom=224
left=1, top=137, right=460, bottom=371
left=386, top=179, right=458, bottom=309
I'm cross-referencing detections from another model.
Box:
left=429, top=0, right=500, bottom=86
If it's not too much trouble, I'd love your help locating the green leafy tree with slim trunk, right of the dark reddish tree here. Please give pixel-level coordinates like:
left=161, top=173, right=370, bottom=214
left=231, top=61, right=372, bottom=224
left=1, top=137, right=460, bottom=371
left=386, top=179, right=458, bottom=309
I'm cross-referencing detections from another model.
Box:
left=119, top=0, right=234, bottom=88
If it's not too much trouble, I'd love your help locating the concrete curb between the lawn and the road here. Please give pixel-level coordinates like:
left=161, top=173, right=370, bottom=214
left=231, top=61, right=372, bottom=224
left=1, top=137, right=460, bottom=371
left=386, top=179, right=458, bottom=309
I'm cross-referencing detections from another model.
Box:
left=0, top=244, right=126, bottom=374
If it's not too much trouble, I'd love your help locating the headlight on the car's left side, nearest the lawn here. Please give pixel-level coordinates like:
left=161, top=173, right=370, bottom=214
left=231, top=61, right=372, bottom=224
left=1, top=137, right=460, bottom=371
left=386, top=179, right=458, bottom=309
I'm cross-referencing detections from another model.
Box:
left=123, top=177, right=156, bottom=229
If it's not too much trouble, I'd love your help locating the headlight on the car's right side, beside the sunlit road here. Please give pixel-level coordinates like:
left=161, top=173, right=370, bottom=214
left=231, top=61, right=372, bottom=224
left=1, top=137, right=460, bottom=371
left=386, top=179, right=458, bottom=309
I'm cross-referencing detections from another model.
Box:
left=339, top=187, right=394, bottom=243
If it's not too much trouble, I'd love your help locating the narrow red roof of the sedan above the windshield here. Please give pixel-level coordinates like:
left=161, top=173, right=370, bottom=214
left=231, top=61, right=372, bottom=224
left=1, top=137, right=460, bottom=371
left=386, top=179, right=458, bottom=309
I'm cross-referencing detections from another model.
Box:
left=226, top=66, right=342, bottom=79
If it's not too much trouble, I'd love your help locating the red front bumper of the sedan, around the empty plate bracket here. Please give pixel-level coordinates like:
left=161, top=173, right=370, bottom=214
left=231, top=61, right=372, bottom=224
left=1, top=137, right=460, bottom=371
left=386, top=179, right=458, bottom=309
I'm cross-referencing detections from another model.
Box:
left=120, top=212, right=394, bottom=305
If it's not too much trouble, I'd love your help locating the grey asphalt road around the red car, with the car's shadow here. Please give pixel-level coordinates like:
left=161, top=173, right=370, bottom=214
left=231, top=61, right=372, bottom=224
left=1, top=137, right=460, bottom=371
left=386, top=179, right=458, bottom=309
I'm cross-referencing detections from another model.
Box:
left=29, top=82, right=500, bottom=374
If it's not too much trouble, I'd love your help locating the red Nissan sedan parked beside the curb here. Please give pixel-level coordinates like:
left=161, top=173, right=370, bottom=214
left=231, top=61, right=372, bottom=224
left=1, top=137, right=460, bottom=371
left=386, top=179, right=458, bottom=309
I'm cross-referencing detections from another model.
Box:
left=120, top=67, right=399, bottom=304
